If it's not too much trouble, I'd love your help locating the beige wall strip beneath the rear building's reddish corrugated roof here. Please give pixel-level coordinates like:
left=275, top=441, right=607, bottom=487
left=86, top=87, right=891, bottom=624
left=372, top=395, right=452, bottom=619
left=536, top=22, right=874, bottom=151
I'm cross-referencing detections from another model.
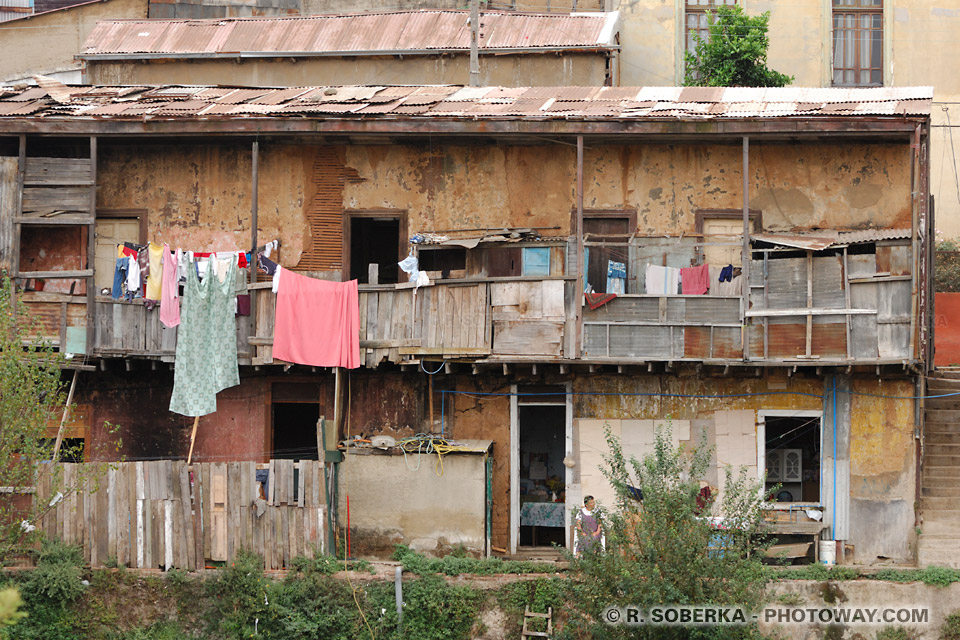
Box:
left=84, top=53, right=607, bottom=87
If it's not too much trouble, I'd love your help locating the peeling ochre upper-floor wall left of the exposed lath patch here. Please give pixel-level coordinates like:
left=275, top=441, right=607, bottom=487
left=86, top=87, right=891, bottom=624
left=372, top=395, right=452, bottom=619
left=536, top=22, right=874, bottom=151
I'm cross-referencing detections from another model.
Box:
left=97, top=142, right=317, bottom=266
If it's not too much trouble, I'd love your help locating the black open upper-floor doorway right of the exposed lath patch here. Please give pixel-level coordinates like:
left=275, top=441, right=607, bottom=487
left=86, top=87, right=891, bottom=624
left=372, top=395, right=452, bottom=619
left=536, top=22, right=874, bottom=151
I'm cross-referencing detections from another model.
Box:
left=344, top=211, right=406, bottom=284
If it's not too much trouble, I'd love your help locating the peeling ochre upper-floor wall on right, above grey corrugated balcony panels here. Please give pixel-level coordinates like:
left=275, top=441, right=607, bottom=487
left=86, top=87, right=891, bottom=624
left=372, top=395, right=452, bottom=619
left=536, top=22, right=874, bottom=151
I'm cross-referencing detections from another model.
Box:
left=584, top=144, right=910, bottom=235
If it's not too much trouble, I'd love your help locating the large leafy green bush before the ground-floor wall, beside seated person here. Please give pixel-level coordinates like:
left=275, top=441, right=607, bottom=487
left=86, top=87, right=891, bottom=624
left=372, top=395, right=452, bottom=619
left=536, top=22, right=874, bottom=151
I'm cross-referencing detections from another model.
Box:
left=564, top=428, right=769, bottom=639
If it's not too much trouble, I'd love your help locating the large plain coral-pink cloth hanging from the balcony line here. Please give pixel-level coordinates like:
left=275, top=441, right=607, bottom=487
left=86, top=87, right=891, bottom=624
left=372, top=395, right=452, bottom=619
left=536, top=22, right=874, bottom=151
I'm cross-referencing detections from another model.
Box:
left=273, top=269, right=360, bottom=369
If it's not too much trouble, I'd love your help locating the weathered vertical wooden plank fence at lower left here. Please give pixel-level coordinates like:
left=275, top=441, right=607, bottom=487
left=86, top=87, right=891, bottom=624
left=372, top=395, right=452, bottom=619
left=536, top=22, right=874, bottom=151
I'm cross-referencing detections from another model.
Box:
left=36, top=460, right=326, bottom=570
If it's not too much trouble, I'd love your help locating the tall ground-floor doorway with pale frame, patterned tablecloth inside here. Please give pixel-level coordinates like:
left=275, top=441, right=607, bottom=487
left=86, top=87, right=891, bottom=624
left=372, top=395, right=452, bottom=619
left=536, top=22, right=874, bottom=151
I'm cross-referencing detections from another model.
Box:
left=510, top=383, right=579, bottom=554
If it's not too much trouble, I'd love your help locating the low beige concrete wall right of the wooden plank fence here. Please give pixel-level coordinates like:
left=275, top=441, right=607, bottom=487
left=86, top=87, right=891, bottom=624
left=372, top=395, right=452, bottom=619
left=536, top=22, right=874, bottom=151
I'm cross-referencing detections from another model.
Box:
left=340, top=453, right=486, bottom=555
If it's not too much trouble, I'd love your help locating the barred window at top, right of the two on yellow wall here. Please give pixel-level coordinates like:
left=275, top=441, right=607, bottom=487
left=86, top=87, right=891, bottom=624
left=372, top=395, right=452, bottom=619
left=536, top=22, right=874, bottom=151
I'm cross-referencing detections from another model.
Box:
left=833, top=0, right=883, bottom=86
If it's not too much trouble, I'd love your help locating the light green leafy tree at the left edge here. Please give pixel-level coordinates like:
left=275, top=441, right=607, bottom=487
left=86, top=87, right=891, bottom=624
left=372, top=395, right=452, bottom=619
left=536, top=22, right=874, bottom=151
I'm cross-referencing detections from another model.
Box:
left=0, top=274, right=116, bottom=565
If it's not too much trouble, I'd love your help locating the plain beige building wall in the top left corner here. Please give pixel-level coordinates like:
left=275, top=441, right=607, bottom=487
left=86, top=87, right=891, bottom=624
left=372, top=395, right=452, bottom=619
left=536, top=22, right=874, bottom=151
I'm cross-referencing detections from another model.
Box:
left=0, top=0, right=147, bottom=82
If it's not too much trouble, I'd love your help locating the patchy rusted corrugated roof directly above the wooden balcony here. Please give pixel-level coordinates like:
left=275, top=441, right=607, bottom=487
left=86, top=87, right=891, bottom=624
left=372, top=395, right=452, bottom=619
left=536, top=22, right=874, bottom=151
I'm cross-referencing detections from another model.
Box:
left=0, top=81, right=932, bottom=131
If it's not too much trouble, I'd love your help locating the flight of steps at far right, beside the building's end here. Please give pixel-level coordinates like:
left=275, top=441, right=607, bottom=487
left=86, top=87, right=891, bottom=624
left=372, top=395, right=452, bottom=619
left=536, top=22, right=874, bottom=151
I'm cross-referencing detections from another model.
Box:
left=917, top=369, right=960, bottom=568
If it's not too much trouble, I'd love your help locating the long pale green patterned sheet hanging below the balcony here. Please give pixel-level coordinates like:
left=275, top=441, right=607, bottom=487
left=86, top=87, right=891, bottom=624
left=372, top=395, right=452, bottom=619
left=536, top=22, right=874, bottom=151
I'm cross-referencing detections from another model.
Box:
left=170, top=262, right=240, bottom=416
